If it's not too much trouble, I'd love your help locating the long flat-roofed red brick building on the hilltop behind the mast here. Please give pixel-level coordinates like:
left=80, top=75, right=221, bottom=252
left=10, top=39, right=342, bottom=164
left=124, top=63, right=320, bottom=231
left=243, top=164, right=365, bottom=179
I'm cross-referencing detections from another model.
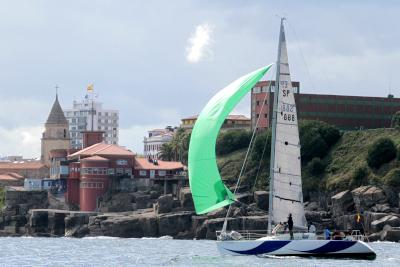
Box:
left=251, top=81, right=400, bottom=130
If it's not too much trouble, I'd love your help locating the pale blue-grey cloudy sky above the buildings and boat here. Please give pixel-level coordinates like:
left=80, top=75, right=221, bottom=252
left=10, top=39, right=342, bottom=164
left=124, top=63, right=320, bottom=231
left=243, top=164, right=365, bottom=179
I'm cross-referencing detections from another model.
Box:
left=0, top=0, right=400, bottom=157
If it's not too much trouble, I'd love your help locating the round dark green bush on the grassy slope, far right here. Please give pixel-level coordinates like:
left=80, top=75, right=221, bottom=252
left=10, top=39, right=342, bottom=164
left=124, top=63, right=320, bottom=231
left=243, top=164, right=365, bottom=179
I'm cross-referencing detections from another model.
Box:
left=367, top=137, right=397, bottom=168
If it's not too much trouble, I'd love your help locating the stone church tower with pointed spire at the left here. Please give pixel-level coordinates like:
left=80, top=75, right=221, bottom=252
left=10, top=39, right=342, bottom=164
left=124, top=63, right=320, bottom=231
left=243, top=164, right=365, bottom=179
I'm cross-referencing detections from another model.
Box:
left=40, top=95, right=70, bottom=167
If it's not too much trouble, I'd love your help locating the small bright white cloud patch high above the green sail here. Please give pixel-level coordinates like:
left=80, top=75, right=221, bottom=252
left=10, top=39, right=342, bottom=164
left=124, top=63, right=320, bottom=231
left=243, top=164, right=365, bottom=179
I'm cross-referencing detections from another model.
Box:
left=186, top=23, right=214, bottom=63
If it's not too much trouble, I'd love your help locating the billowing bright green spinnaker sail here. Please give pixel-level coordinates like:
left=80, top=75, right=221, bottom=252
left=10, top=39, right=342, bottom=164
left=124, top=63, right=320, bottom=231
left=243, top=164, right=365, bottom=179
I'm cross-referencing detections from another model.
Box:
left=189, top=64, right=272, bottom=214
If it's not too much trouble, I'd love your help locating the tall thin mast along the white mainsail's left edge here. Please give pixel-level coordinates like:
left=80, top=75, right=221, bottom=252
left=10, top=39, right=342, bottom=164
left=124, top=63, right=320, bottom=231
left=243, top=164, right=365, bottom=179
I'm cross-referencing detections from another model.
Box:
left=268, top=17, right=285, bottom=234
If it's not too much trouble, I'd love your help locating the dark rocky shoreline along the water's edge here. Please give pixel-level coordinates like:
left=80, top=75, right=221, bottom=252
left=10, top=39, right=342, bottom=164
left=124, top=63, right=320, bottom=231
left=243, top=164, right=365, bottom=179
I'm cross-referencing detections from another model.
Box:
left=0, top=186, right=400, bottom=242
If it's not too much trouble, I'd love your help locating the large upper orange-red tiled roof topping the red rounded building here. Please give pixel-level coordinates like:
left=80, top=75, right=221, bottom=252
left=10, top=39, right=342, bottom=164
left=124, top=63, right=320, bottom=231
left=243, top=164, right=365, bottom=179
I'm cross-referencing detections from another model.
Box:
left=68, top=143, right=135, bottom=158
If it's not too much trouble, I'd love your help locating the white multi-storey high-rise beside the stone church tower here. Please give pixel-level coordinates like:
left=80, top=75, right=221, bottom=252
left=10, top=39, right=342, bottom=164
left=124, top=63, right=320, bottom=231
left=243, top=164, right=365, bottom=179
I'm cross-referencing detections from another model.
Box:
left=64, top=95, right=119, bottom=149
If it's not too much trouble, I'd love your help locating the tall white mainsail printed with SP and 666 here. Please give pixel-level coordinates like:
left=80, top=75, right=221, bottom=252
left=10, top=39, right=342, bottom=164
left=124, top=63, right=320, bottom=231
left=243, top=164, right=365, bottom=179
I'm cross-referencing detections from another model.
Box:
left=269, top=20, right=307, bottom=228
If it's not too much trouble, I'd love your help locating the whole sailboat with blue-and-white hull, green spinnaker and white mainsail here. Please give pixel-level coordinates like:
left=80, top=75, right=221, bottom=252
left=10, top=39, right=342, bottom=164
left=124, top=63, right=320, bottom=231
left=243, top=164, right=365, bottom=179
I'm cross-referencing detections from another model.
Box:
left=188, top=18, right=376, bottom=259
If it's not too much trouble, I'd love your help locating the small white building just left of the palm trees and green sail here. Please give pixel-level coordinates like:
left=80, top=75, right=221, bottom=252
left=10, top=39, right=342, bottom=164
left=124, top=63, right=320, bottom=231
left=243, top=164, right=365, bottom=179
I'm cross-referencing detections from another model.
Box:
left=143, top=127, right=174, bottom=159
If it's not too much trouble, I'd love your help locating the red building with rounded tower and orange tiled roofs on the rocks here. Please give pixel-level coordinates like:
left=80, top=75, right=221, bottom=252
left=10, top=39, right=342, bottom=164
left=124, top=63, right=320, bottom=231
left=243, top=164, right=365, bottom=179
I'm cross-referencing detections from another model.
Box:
left=65, top=139, right=185, bottom=211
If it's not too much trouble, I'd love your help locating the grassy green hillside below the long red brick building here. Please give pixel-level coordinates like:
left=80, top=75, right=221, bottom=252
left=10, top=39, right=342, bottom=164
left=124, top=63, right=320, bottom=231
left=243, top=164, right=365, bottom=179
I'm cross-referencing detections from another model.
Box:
left=218, top=129, right=400, bottom=192
